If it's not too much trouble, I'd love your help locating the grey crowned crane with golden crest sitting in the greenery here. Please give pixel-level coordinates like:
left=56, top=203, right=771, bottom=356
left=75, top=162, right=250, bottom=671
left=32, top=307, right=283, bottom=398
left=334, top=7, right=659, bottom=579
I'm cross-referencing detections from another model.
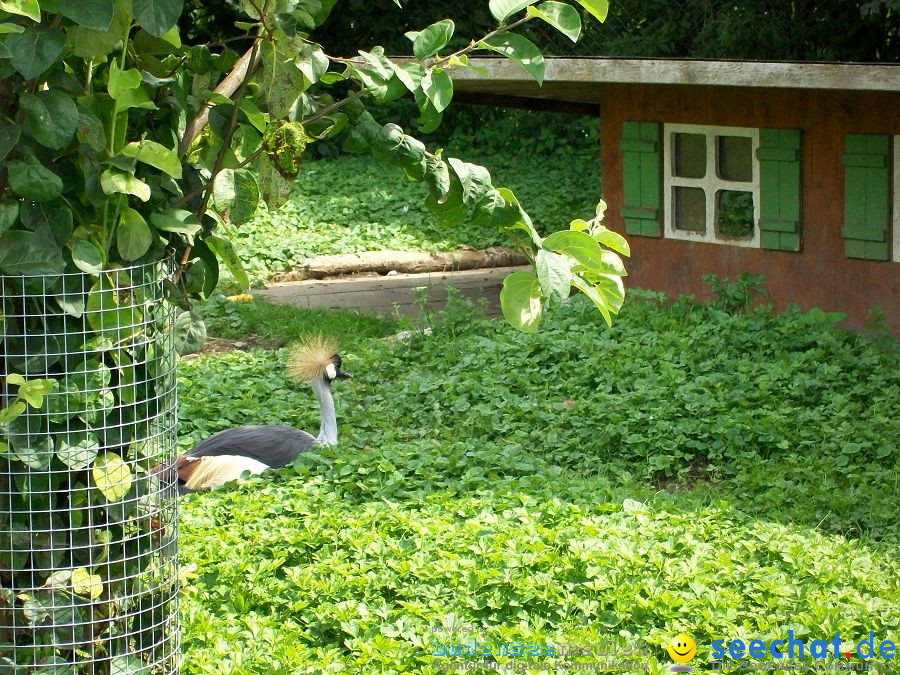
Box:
left=175, top=337, right=352, bottom=494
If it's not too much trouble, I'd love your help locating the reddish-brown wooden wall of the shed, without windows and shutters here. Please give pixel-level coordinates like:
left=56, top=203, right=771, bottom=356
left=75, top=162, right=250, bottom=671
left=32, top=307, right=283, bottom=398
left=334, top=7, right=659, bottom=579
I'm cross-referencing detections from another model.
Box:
left=600, top=84, right=900, bottom=334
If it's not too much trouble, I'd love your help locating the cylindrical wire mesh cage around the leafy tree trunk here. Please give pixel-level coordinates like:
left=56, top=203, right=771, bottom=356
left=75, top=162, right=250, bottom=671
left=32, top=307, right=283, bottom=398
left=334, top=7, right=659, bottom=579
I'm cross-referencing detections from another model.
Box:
left=0, top=261, right=179, bottom=674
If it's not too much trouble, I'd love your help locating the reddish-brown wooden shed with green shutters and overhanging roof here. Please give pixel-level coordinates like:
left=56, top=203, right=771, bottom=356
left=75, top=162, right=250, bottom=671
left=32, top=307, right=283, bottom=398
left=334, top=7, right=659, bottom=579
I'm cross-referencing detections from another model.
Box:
left=456, top=58, right=900, bottom=333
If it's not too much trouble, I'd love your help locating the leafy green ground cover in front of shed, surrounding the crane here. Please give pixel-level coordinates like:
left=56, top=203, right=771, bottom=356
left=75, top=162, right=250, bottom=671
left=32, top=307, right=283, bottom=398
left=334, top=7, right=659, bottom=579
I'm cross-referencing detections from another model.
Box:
left=180, top=293, right=900, bottom=673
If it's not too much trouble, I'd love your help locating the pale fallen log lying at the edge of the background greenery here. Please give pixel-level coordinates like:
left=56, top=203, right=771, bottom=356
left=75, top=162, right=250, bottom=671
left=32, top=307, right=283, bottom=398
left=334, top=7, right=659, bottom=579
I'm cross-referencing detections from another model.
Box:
left=270, top=246, right=528, bottom=283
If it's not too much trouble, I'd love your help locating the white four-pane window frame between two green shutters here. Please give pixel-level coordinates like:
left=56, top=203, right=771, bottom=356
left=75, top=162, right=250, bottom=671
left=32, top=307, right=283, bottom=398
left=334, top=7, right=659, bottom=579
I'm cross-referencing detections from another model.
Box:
left=663, top=124, right=760, bottom=248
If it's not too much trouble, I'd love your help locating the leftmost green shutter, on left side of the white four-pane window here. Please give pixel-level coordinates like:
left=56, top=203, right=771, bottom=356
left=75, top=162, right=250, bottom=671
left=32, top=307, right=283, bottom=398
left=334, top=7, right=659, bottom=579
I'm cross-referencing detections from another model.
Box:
left=619, top=122, right=660, bottom=237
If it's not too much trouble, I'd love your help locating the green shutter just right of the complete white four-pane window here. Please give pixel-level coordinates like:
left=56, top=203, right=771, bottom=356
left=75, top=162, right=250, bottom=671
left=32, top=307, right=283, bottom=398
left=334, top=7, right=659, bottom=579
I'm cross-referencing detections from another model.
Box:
left=756, top=129, right=800, bottom=251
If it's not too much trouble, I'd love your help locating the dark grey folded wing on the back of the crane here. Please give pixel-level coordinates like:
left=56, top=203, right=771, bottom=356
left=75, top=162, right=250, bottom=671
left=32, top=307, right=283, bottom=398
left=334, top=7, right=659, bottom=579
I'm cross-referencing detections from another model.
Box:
left=187, top=424, right=316, bottom=469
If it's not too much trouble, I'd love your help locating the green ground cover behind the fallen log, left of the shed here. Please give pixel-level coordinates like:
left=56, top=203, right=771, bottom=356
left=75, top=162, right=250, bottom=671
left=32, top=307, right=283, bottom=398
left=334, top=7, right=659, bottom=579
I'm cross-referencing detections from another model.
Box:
left=234, top=111, right=600, bottom=281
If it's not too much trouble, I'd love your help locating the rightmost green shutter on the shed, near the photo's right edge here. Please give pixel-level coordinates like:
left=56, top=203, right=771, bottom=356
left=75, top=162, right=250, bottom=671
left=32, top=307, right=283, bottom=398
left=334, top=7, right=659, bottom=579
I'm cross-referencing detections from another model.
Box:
left=841, top=134, right=891, bottom=260
